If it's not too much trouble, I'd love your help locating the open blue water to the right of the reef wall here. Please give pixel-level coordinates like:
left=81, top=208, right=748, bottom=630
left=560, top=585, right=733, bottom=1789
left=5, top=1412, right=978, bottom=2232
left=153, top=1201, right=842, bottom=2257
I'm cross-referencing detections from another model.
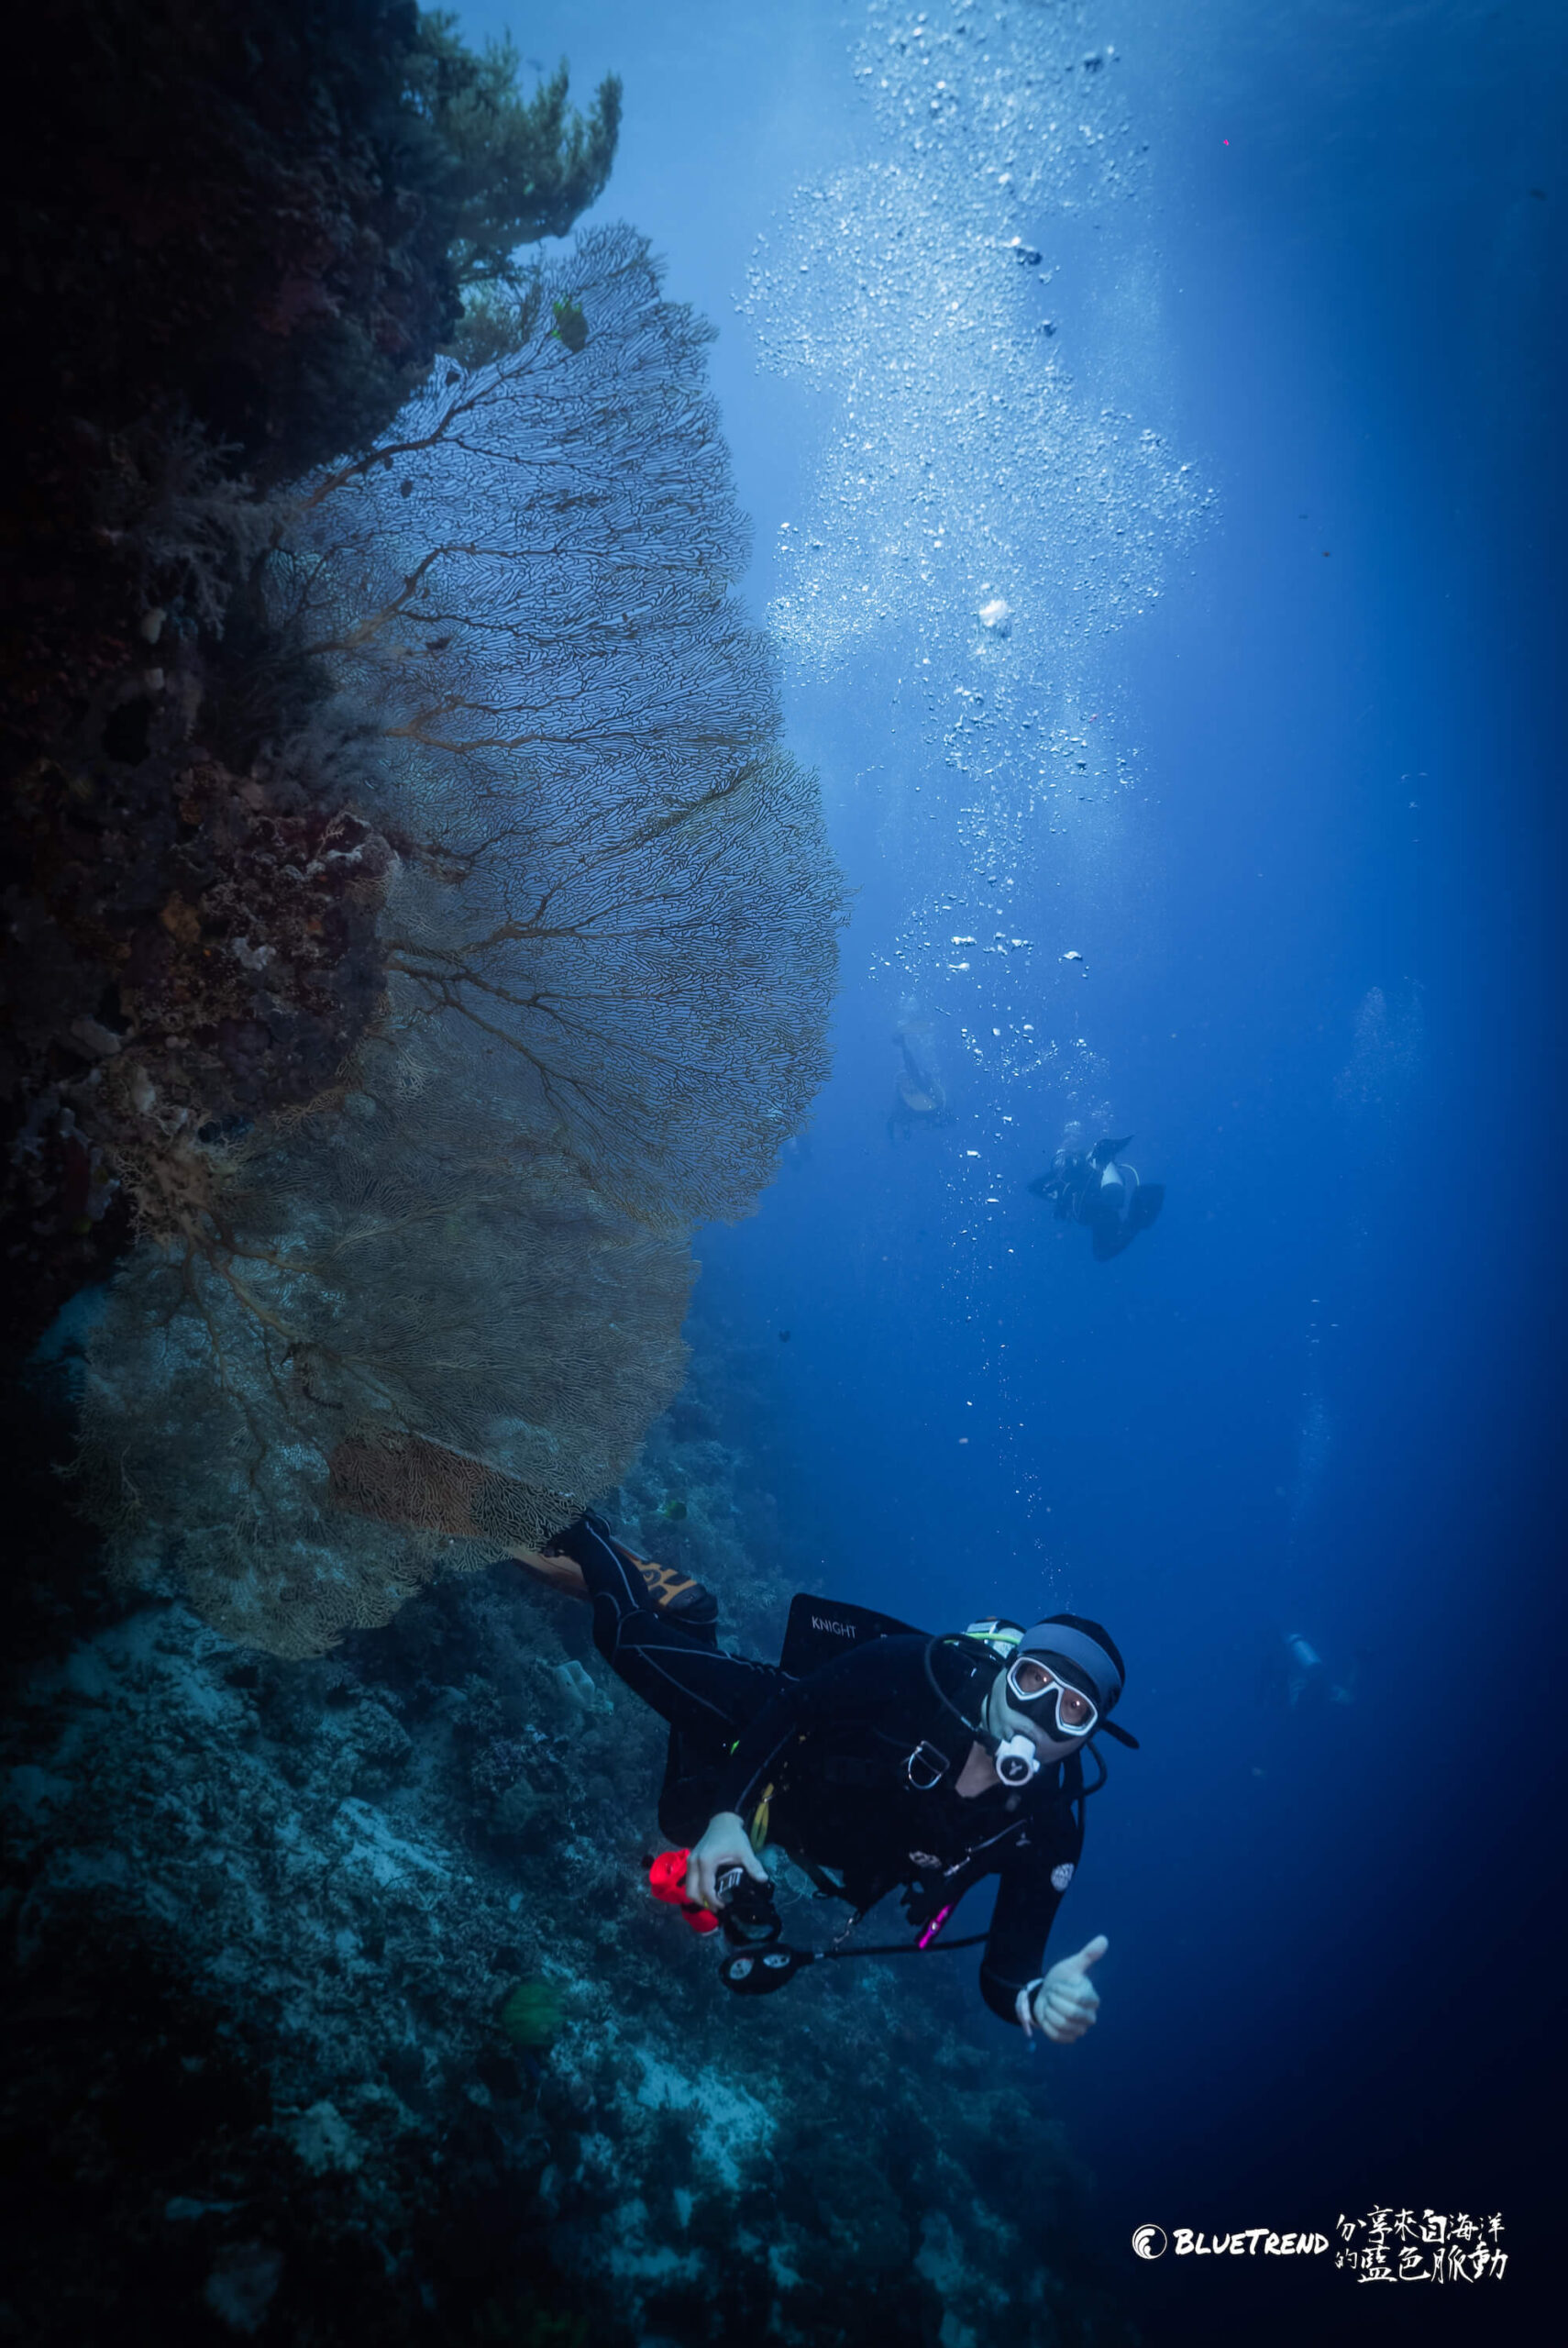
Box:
left=462, top=0, right=1568, bottom=2339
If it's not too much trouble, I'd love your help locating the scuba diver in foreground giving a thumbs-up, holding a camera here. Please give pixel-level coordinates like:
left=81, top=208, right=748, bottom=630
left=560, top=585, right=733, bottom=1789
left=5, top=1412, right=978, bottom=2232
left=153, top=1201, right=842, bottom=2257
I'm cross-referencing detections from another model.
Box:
left=512, top=1517, right=1139, bottom=2045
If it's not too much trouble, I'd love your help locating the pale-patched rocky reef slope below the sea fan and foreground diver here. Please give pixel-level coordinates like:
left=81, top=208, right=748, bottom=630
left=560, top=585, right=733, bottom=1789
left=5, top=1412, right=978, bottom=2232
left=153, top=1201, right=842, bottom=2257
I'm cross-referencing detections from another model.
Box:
left=0, top=1353, right=1132, bottom=2348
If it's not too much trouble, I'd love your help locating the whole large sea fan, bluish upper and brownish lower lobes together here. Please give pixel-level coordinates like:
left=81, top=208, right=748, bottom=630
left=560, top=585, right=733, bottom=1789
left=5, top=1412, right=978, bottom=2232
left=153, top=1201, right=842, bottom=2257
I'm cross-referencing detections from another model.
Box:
left=84, top=230, right=840, bottom=1656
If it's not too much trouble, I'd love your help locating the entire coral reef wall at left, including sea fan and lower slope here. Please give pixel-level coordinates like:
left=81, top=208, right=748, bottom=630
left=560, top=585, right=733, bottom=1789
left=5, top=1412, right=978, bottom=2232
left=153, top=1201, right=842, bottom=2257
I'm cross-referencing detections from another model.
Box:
left=0, top=22, right=1124, bottom=2348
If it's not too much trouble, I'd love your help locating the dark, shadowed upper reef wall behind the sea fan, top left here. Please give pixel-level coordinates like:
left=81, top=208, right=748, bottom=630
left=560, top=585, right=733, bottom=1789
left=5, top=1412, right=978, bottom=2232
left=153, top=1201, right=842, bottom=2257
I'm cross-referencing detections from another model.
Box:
left=0, top=0, right=620, bottom=1367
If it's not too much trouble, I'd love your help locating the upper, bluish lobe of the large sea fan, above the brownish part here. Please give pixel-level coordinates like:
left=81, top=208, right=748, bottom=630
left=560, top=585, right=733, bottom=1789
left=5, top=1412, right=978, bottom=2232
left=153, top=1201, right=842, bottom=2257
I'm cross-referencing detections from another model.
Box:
left=291, top=227, right=838, bottom=1228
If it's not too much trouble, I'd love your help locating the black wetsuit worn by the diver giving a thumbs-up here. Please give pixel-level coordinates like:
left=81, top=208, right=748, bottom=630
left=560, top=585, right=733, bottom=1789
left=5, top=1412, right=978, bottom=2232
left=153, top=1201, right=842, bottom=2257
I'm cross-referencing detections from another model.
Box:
left=557, top=1519, right=1082, bottom=2021
